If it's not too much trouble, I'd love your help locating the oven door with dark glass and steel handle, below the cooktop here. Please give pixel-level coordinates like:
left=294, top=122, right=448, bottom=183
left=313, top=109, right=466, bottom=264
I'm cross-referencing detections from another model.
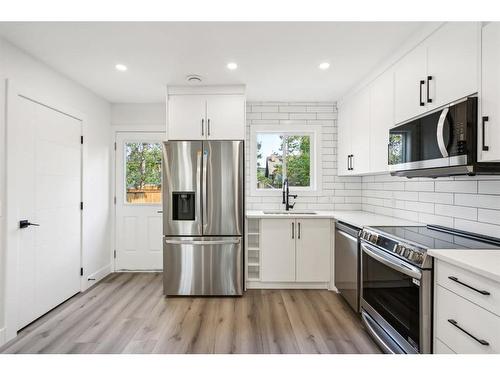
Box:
left=361, top=241, right=422, bottom=353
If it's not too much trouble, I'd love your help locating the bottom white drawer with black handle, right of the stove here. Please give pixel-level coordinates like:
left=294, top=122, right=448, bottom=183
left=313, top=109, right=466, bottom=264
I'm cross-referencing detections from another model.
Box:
left=434, top=285, right=500, bottom=354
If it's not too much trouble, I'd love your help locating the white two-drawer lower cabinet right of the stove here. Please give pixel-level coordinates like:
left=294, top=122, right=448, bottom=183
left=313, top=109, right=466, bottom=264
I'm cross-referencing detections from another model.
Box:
left=434, top=260, right=500, bottom=354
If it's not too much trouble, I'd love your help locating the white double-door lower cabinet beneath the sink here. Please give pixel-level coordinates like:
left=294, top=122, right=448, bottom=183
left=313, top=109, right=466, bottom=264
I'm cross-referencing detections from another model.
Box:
left=260, top=219, right=331, bottom=283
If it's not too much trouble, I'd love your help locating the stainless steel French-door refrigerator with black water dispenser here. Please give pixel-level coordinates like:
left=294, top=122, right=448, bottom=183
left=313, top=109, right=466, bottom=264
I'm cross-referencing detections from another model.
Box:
left=163, top=141, right=245, bottom=296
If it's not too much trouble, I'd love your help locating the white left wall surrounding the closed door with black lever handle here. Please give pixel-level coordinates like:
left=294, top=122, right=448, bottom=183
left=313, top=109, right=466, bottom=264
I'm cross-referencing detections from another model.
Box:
left=0, top=38, right=111, bottom=340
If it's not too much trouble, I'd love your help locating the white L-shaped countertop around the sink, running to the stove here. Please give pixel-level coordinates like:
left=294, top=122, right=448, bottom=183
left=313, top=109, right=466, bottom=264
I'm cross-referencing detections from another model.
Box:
left=246, top=210, right=424, bottom=227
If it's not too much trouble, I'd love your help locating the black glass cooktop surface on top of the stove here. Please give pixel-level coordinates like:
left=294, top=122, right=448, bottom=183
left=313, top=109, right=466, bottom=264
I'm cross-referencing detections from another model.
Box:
left=370, top=225, right=500, bottom=250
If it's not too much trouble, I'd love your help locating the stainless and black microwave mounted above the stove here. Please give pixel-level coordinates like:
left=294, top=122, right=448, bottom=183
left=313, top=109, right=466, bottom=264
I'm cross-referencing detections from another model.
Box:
left=388, top=97, right=500, bottom=177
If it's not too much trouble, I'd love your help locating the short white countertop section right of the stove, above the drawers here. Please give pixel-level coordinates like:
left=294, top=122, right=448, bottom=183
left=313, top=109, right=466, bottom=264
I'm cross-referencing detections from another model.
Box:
left=427, top=249, right=500, bottom=282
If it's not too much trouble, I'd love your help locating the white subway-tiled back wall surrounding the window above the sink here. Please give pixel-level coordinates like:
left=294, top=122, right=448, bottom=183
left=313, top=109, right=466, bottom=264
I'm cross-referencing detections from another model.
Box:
left=245, top=102, right=361, bottom=210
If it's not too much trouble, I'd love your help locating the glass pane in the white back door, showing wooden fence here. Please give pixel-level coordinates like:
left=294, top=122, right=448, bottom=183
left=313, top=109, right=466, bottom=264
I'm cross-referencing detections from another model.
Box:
left=125, top=142, right=162, bottom=204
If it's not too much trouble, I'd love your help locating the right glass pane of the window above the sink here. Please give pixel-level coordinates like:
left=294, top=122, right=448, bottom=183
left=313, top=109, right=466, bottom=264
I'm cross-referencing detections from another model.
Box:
left=285, top=135, right=311, bottom=187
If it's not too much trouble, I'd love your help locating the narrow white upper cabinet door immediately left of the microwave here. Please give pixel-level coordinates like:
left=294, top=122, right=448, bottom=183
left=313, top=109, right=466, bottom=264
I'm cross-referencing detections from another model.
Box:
left=369, top=70, right=394, bottom=173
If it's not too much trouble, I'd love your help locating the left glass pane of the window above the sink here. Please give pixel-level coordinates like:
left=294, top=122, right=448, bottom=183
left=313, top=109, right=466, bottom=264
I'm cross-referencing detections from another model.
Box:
left=257, top=133, right=283, bottom=189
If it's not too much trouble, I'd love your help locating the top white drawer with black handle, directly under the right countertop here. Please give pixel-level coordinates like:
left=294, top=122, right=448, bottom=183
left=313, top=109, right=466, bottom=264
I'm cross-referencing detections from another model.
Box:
left=436, top=260, right=500, bottom=316
